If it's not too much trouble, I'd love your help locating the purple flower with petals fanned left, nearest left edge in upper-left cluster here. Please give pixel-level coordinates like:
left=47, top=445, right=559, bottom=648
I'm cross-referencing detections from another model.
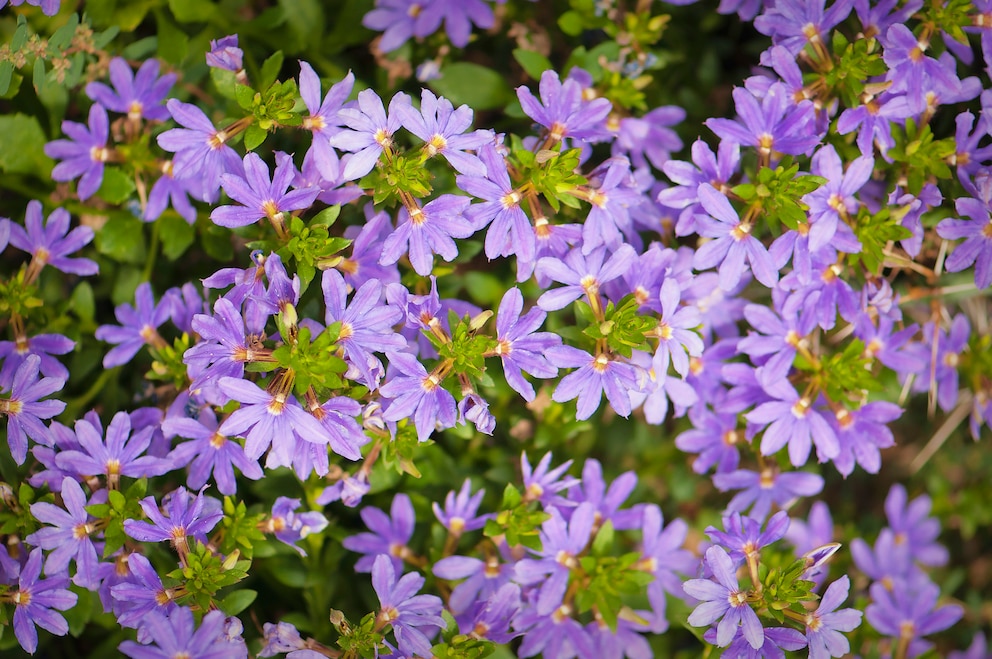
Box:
left=45, top=103, right=111, bottom=199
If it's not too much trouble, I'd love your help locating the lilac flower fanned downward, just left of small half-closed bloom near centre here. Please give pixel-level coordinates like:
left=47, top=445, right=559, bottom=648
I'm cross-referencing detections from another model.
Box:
left=379, top=353, right=457, bottom=442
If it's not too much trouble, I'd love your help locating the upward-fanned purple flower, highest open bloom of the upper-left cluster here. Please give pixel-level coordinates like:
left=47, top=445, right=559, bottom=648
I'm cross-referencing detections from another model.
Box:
left=86, top=57, right=176, bottom=121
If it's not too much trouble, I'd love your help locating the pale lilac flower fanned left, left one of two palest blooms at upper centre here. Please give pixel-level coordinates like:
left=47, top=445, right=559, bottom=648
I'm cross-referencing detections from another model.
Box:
left=330, top=89, right=410, bottom=181
